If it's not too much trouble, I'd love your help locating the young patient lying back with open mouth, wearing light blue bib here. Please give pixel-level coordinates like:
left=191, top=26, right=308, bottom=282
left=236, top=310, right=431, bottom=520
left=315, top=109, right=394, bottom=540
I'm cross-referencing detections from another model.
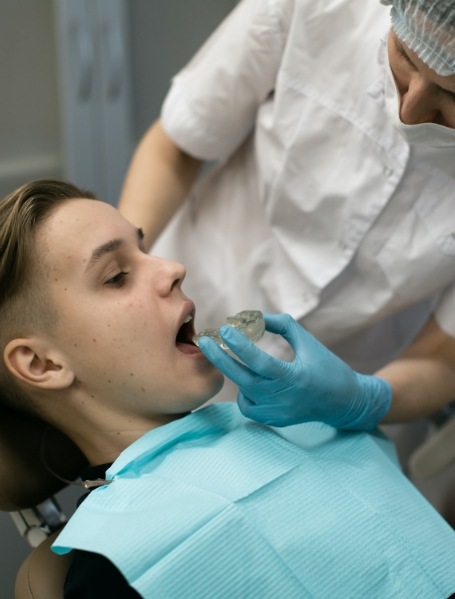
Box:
left=0, top=181, right=455, bottom=599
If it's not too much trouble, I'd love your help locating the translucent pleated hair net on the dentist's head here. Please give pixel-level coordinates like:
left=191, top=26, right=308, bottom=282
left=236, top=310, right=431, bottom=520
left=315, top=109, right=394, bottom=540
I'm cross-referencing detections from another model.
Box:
left=381, top=0, right=455, bottom=76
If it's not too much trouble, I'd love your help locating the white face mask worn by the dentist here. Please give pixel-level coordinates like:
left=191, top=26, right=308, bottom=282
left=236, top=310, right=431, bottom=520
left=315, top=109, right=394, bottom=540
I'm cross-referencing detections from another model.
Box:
left=384, top=45, right=455, bottom=148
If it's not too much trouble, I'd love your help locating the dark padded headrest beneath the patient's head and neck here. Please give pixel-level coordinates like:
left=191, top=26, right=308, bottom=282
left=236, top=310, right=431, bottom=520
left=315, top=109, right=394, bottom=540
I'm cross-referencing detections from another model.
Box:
left=0, top=407, right=87, bottom=511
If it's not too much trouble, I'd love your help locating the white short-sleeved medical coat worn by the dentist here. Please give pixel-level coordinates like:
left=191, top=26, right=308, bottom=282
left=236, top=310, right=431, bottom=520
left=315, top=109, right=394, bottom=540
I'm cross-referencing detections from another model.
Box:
left=153, top=0, right=455, bottom=372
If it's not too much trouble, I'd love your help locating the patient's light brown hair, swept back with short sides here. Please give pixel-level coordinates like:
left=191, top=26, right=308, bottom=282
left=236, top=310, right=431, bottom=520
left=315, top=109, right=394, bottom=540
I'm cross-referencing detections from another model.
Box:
left=0, top=179, right=96, bottom=411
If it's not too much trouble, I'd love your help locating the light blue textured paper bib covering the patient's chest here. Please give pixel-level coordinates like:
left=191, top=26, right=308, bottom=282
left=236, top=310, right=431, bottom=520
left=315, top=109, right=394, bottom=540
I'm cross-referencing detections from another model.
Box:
left=53, top=404, right=455, bottom=599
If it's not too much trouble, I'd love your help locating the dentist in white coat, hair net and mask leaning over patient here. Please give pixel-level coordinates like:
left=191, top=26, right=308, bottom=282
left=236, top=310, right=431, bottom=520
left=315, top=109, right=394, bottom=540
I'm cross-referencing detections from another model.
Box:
left=120, top=0, right=455, bottom=429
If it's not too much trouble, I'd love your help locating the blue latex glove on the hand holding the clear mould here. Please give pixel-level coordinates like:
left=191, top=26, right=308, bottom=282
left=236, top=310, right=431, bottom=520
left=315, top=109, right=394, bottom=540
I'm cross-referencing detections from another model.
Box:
left=199, top=314, right=392, bottom=430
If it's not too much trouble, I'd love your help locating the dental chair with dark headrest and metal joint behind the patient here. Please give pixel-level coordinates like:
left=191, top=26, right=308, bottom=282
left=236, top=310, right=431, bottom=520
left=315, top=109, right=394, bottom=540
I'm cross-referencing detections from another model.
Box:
left=0, top=408, right=87, bottom=599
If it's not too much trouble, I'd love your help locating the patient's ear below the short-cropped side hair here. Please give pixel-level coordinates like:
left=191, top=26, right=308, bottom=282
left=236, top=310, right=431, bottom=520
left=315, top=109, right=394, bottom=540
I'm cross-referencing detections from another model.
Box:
left=3, top=338, right=75, bottom=389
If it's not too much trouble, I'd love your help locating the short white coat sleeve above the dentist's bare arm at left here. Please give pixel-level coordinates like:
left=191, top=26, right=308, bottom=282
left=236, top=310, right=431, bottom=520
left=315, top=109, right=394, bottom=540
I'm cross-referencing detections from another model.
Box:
left=161, top=0, right=294, bottom=160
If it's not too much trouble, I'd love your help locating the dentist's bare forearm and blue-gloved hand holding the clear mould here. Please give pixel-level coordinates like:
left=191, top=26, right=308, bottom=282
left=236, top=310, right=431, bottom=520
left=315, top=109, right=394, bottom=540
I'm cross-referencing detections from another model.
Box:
left=199, top=315, right=455, bottom=430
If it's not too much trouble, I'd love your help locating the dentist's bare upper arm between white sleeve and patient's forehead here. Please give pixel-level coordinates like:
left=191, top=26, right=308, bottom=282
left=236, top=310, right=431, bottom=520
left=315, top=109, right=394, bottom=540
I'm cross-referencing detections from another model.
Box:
left=118, top=121, right=202, bottom=249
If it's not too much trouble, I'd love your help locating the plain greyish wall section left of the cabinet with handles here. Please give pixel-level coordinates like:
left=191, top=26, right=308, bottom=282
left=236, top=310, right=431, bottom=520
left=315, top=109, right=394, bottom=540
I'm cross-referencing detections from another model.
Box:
left=0, top=0, right=62, bottom=195
